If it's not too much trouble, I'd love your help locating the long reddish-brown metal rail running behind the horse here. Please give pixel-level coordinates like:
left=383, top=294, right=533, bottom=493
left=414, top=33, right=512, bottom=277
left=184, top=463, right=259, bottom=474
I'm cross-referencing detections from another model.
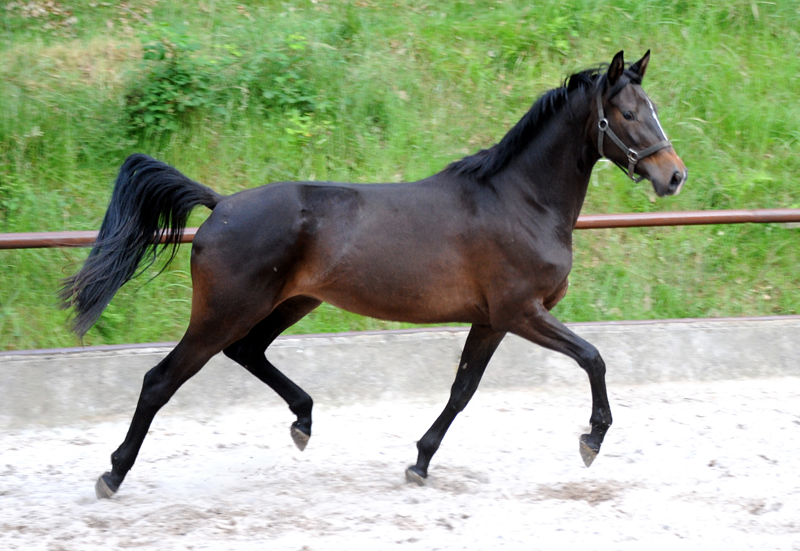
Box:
left=0, top=209, right=800, bottom=249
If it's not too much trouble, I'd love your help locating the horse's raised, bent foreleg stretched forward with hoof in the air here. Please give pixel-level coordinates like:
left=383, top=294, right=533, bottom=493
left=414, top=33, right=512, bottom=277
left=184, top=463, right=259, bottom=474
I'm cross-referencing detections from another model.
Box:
left=511, top=301, right=612, bottom=467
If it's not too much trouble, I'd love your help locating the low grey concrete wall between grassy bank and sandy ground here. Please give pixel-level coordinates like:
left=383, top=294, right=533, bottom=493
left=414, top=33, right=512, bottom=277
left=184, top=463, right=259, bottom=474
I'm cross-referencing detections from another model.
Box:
left=0, top=316, right=800, bottom=428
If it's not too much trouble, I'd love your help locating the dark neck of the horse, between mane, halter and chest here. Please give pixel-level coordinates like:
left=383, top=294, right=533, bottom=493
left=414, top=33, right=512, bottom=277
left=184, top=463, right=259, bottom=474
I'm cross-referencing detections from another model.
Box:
left=495, top=94, right=600, bottom=231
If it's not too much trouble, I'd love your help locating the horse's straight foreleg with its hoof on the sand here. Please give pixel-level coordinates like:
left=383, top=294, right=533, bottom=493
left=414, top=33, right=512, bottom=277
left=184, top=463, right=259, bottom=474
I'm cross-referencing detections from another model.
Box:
left=406, top=325, right=505, bottom=485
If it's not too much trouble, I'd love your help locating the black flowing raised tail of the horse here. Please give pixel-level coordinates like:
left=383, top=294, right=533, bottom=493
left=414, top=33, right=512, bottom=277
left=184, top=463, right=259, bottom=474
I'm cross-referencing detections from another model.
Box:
left=59, top=154, right=222, bottom=337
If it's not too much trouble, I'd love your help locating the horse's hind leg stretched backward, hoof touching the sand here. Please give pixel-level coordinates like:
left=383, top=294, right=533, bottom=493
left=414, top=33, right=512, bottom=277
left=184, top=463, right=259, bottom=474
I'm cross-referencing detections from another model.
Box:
left=95, top=337, right=218, bottom=498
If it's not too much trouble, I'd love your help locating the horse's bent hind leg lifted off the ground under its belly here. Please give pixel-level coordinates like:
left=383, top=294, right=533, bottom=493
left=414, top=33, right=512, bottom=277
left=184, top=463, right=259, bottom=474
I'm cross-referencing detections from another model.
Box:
left=224, top=296, right=321, bottom=451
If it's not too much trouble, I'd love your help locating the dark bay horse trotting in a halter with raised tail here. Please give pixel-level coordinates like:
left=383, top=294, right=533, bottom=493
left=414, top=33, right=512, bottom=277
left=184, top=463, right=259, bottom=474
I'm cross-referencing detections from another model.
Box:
left=61, top=51, right=687, bottom=497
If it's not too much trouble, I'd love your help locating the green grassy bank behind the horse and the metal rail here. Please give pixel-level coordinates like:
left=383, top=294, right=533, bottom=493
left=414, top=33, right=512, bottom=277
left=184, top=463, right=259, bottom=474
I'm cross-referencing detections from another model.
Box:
left=0, top=0, right=800, bottom=349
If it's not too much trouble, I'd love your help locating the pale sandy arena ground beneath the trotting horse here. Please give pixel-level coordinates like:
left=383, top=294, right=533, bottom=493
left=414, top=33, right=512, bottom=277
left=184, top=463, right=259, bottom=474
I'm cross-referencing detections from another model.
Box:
left=0, top=378, right=800, bottom=551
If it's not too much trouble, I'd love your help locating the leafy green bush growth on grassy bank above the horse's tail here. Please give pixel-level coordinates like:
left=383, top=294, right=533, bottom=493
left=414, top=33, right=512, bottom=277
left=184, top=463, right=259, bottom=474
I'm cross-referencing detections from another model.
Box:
left=120, top=29, right=327, bottom=136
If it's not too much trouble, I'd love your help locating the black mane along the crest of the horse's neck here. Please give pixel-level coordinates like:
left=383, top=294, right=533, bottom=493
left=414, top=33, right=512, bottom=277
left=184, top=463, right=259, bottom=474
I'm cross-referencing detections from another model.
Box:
left=445, top=64, right=641, bottom=180
